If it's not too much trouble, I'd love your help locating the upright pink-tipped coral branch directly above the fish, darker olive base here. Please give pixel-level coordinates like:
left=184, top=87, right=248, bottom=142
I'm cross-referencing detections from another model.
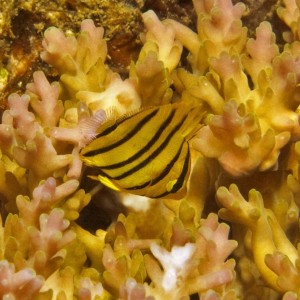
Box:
left=130, top=11, right=182, bottom=106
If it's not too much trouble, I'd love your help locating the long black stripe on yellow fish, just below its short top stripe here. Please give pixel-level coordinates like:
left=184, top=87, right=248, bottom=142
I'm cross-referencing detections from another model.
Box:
left=84, top=109, right=158, bottom=157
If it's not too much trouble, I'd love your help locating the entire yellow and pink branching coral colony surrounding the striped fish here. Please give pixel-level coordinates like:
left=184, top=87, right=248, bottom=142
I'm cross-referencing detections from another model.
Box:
left=0, top=0, right=300, bottom=300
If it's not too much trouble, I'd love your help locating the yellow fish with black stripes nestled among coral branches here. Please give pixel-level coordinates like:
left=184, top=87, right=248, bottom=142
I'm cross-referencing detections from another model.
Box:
left=80, top=102, right=203, bottom=198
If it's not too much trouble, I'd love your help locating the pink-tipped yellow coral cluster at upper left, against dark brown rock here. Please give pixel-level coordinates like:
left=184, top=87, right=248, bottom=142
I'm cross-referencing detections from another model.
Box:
left=41, top=20, right=107, bottom=96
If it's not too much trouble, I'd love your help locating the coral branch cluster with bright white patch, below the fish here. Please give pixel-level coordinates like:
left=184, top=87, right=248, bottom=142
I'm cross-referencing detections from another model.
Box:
left=145, top=214, right=236, bottom=299
